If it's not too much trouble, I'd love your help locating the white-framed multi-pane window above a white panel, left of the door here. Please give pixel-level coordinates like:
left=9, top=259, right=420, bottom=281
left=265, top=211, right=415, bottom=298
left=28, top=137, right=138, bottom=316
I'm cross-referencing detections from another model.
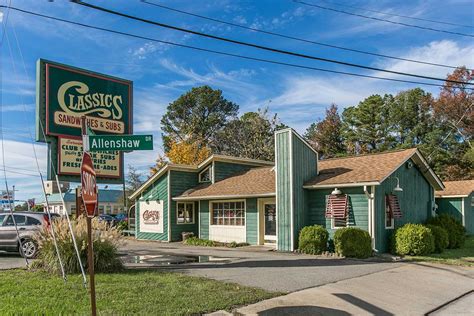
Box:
left=211, top=201, right=245, bottom=226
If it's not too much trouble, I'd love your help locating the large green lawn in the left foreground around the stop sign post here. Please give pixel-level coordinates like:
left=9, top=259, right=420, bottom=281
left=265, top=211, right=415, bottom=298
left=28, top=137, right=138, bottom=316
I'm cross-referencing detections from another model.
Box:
left=0, top=270, right=280, bottom=315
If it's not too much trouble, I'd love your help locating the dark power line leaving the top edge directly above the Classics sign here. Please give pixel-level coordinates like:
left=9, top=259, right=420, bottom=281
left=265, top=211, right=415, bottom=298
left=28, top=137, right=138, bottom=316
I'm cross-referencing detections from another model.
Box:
left=68, top=0, right=472, bottom=85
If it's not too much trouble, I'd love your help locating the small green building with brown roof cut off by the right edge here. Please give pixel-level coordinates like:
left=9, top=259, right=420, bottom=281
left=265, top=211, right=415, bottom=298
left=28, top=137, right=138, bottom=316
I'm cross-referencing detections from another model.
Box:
left=436, top=180, right=474, bottom=235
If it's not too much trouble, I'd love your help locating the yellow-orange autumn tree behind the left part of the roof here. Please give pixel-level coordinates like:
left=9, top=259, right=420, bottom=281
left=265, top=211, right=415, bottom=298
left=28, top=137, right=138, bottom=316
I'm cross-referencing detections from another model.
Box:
left=167, top=141, right=211, bottom=165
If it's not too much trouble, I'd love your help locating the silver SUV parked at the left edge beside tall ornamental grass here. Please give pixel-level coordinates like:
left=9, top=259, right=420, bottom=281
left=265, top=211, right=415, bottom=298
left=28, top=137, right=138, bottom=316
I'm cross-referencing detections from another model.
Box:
left=0, top=212, right=60, bottom=259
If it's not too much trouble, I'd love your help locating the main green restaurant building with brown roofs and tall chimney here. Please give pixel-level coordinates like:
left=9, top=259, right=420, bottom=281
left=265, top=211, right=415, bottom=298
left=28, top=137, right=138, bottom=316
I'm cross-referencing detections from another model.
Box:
left=130, top=128, right=444, bottom=252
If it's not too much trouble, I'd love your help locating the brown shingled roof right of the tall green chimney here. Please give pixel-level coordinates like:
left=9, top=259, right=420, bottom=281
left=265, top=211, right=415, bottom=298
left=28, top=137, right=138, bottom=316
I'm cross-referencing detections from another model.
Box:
left=304, top=148, right=443, bottom=189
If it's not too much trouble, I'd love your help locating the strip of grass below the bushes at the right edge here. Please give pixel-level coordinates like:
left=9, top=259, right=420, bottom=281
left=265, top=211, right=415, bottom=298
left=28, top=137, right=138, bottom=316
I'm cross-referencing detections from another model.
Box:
left=406, top=236, right=474, bottom=267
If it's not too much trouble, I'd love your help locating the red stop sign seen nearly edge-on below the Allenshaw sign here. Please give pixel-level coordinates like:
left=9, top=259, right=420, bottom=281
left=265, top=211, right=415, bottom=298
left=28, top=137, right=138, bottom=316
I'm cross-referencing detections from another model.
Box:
left=81, top=152, right=97, bottom=217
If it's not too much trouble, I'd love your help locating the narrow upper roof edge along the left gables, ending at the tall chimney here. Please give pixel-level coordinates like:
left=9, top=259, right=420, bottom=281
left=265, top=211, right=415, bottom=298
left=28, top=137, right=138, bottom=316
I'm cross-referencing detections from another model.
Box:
left=129, top=154, right=274, bottom=200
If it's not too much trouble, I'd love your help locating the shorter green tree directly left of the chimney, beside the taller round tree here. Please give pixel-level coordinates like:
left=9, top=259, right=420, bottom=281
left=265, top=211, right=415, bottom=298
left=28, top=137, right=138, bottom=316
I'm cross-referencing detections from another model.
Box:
left=212, top=108, right=284, bottom=161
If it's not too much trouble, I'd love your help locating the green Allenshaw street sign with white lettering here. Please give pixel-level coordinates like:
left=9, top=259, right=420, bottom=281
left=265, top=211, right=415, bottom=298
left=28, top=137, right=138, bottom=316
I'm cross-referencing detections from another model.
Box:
left=86, top=135, right=153, bottom=151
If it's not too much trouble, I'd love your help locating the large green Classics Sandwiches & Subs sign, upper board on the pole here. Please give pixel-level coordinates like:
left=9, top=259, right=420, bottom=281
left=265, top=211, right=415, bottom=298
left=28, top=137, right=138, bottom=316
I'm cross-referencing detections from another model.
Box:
left=37, top=60, right=133, bottom=141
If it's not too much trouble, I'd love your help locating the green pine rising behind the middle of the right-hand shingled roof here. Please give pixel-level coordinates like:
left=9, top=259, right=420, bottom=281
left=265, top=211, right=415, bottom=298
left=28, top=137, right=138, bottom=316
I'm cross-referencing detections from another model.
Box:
left=342, top=94, right=393, bottom=153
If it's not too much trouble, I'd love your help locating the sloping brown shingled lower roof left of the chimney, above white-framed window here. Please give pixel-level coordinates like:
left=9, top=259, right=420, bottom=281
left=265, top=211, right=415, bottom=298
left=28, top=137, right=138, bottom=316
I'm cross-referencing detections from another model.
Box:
left=173, top=167, right=275, bottom=201
